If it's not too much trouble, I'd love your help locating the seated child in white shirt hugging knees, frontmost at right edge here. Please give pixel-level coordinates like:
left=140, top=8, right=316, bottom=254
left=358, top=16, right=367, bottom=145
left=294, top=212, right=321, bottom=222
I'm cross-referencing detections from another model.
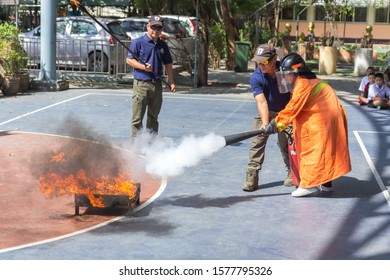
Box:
left=367, top=73, right=390, bottom=109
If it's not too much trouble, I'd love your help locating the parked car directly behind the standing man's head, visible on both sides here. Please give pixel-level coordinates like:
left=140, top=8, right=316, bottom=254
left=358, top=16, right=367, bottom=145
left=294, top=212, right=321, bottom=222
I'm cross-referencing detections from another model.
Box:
left=120, top=17, right=189, bottom=41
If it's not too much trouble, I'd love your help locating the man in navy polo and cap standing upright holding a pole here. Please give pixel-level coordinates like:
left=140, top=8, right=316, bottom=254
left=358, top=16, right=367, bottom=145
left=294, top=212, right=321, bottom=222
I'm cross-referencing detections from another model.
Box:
left=126, top=16, right=176, bottom=137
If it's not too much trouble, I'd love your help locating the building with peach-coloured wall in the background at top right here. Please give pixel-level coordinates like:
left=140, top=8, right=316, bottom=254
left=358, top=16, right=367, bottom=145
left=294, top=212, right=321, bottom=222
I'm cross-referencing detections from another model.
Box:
left=279, top=0, right=390, bottom=44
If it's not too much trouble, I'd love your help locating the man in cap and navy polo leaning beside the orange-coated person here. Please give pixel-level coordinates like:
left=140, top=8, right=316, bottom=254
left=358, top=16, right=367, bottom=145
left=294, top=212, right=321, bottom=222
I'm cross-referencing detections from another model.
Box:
left=242, top=44, right=293, bottom=191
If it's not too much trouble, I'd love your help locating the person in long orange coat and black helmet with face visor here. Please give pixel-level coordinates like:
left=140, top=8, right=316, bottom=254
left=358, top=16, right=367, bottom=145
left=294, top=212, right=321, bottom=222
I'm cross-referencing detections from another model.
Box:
left=265, top=53, right=351, bottom=197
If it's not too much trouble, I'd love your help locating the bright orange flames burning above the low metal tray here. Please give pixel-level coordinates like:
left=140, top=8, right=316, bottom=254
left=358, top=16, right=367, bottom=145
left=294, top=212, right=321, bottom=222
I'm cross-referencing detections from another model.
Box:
left=39, top=152, right=137, bottom=207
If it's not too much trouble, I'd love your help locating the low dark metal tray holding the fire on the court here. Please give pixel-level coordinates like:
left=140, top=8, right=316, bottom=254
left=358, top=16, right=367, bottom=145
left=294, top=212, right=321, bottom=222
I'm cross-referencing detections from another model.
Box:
left=74, top=183, right=141, bottom=216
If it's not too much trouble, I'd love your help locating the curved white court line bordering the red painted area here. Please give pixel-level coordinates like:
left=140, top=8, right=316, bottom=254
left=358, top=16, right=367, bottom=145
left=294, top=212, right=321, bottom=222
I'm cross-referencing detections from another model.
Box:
left=0, top=130, right=168, bottom=254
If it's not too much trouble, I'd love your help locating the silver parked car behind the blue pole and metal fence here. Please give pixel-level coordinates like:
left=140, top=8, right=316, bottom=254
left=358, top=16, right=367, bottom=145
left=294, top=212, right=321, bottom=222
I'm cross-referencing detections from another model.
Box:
left=20, top=16, right=129, bottom=72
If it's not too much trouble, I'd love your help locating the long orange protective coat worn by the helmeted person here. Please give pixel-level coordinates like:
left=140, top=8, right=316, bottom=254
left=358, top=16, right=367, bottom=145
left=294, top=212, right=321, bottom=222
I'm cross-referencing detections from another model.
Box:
left=275, top=77, right=351, bottom=188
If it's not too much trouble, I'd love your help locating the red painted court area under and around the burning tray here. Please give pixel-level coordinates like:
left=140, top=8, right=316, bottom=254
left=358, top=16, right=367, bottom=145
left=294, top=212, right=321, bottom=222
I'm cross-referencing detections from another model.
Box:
left=0, top=132, right=160, bottom=250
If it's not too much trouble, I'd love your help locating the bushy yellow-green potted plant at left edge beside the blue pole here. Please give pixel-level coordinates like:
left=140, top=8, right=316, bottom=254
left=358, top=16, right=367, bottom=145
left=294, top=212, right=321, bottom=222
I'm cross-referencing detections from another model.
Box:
left=0, top=22, right=28, bottom=95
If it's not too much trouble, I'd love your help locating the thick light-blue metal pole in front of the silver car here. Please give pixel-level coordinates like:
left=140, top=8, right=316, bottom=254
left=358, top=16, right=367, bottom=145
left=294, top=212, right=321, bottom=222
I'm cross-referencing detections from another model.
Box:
left=39, top=0, right=57, bottom=81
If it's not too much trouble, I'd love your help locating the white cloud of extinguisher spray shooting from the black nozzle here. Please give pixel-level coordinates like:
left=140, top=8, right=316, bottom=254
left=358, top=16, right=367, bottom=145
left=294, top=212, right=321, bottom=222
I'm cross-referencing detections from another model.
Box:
left=133, top=133, right=226, bottom=177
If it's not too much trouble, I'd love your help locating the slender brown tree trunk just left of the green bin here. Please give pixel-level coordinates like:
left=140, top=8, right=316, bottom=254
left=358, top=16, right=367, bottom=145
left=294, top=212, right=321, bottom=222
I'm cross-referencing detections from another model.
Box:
left=216, top=0, right=239, bottom=70
